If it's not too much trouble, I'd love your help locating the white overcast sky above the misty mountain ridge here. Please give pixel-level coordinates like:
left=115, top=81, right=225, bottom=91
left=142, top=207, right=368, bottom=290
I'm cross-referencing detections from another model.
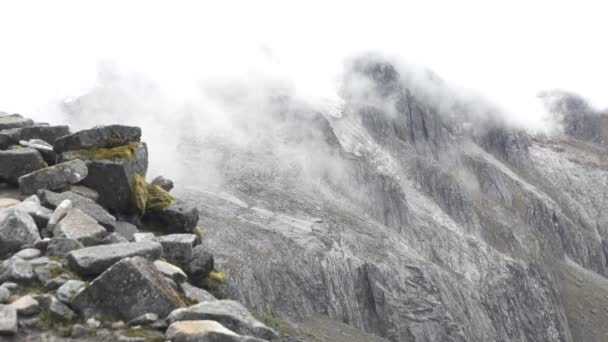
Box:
left=0, top=0, right=608, bottom=128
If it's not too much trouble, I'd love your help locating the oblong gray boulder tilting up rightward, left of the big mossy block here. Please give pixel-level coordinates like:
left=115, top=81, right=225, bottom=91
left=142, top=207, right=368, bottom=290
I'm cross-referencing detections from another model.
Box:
left=18, top=159, right=88, bottom=196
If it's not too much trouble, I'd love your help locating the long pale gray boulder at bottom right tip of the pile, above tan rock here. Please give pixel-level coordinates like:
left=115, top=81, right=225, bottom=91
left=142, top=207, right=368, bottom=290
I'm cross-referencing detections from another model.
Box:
left=167, top=300, right=278, bottom=340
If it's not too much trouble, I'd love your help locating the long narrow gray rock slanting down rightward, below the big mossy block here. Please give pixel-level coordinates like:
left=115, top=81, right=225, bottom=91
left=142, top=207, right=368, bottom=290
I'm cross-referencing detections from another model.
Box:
left=37, top=190, right=116, bottom=232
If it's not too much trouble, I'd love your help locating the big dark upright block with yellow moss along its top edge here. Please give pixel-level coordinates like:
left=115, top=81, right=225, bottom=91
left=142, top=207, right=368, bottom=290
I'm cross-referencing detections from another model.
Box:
left=60, top=143, right=148, bottom=215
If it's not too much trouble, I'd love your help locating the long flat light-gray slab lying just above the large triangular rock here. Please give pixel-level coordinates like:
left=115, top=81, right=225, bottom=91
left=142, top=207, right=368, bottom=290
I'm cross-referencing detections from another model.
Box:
left=67, top=241, right=162, bottom=275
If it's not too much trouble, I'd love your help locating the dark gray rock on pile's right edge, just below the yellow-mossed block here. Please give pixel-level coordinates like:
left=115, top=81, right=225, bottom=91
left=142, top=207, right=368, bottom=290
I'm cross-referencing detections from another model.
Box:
left=144, top=198, right=198, bottom=233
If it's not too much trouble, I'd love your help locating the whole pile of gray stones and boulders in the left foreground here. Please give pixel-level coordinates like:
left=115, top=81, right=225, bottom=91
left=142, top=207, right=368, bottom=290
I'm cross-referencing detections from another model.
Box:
left=0, top=114, right=277, bottom=341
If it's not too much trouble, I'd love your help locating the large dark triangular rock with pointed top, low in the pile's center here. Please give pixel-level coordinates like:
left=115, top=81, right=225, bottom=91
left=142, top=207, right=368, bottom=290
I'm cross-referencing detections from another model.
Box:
left=72, top=257, right=184, bottom=321
